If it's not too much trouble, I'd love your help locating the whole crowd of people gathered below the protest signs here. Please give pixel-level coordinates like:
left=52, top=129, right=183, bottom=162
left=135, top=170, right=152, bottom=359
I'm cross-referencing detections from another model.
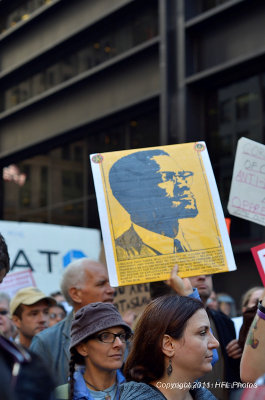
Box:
left=0, top=231, right=265, bottom=400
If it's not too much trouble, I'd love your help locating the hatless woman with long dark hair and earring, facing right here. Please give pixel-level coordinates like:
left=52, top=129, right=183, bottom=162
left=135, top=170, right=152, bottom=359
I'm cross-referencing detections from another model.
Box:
left=120, top=296, right=219, bottom=400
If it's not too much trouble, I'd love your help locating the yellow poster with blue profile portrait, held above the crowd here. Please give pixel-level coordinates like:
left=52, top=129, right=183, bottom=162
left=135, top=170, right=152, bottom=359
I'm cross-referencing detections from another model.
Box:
left=90, top=142, right=236, bottom=286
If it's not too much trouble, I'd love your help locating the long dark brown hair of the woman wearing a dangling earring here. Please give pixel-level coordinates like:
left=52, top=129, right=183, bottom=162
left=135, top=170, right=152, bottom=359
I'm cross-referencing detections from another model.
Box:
left=124, top=295, right=204, bottom=383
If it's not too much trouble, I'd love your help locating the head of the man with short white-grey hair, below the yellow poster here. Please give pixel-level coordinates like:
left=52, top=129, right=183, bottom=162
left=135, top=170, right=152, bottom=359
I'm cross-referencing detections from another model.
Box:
left=61, top=258, right=115, bottom=311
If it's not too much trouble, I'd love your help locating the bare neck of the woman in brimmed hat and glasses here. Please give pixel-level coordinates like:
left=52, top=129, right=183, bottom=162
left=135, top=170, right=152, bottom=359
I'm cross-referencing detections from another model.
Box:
left=84, top=368, right=117, bottom=390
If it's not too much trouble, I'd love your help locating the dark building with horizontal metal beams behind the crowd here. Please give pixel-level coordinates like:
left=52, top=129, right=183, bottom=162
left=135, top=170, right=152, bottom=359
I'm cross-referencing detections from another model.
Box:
left=0, top=0, right=265, bottom=304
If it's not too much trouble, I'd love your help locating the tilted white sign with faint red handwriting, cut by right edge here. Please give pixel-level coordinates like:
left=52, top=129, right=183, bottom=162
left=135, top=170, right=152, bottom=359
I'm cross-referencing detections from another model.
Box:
left=227, top=137, right=265, bottom=225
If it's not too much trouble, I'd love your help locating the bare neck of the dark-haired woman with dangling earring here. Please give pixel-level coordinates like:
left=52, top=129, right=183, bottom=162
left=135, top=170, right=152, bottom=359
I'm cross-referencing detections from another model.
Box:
left=151, top=375, right=193, bottom=400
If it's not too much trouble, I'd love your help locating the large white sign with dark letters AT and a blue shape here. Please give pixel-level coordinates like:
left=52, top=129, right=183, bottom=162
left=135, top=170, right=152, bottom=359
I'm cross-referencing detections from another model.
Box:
left=0, top=221, right=100, bottom=297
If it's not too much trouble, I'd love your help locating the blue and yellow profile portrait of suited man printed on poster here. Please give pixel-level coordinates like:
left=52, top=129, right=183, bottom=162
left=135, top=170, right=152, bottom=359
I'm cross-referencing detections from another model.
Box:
left=109, top=149, right=199, bottom=260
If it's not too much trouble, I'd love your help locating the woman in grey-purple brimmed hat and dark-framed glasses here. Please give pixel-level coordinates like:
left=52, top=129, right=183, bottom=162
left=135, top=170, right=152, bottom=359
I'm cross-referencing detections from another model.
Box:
left=56, top=303, right=132, bottom=400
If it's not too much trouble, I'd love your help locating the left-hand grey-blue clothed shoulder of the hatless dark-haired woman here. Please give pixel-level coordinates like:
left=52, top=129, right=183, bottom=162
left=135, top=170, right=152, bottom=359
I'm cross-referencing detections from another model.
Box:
left=120, top=381, right=165, bottom=400
